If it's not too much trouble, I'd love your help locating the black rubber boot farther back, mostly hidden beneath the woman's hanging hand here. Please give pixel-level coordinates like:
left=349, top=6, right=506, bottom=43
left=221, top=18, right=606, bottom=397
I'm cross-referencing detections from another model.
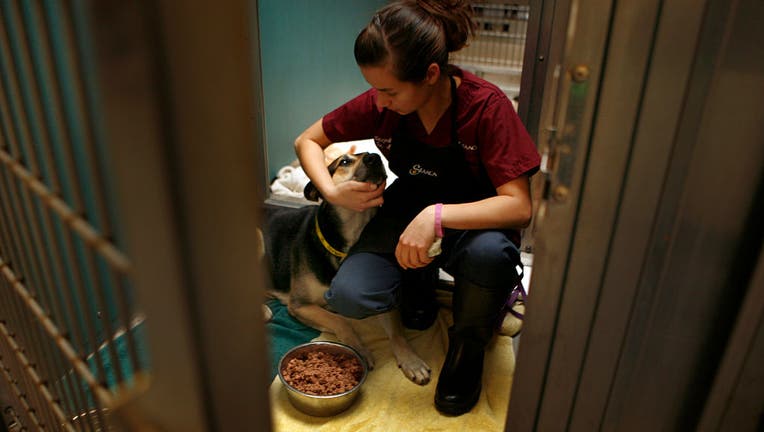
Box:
left=400, top=267, right=438, bottom=330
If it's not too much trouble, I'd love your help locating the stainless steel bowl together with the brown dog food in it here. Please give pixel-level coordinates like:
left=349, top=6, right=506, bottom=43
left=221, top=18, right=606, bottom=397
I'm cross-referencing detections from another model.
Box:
left=278, top=341, right=368, bottom=417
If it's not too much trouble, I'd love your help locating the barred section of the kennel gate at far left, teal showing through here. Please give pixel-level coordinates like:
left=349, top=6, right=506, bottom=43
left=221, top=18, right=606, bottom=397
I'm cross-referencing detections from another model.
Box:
left=0, top=0, right=148, bottom=431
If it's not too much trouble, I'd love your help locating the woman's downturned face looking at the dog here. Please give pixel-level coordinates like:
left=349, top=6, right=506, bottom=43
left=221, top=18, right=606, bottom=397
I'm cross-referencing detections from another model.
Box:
left=361, top=65, right=432, bottom=115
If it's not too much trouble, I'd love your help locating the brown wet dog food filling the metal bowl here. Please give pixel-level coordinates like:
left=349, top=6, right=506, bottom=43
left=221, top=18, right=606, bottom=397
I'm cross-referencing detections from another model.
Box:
left=281, top=351, right=363, bottom=396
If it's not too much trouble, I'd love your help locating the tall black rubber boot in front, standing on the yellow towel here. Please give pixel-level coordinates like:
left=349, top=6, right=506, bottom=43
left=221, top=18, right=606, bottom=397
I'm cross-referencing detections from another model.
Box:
left=435, top=278, right=511, bottom=415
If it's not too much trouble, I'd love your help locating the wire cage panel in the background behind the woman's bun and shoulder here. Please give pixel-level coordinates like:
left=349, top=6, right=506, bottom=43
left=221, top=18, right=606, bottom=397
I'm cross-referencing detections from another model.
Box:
left=451, top=1, right=530, bottom=104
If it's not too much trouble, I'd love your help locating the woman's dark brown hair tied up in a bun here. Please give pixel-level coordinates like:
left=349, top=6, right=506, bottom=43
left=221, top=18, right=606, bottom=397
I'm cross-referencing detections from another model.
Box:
left=354, top=0, right=475, bottom=82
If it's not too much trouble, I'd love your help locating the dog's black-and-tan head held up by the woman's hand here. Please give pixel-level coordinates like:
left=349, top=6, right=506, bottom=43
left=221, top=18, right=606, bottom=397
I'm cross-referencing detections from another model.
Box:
left=303, top=152, right=387, bottom=201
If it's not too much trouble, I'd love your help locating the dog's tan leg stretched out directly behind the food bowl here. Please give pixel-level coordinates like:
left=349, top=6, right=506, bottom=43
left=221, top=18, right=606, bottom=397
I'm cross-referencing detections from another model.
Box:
left=288, top=302, right=374, bottom=369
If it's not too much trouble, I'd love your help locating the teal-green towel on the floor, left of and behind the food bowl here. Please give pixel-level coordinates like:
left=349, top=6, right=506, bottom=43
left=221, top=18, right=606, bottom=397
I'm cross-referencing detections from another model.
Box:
left=266, top=300, right=320, bottom=380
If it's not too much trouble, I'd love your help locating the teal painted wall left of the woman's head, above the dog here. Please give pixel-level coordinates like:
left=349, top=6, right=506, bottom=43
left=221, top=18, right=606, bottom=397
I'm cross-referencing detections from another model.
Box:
left=258, top=0, right=386, bottom=178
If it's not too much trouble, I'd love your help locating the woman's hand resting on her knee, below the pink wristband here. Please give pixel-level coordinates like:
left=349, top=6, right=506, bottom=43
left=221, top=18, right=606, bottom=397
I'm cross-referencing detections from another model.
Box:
left=395, top=206, right=435, bottom=269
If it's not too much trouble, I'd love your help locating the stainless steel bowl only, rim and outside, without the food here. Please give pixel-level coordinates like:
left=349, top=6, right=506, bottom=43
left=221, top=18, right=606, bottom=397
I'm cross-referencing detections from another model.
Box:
left=279, top=341, right=369, bottom=417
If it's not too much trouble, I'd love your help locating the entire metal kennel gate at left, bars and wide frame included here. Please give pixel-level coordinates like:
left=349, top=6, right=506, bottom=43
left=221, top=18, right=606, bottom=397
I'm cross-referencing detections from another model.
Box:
left=0, top=0, right=269, bottom=432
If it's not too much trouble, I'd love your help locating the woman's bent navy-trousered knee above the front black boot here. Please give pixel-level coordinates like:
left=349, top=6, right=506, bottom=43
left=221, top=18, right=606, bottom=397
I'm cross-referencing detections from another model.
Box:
left=446, top=231, right=520, bottom=286
